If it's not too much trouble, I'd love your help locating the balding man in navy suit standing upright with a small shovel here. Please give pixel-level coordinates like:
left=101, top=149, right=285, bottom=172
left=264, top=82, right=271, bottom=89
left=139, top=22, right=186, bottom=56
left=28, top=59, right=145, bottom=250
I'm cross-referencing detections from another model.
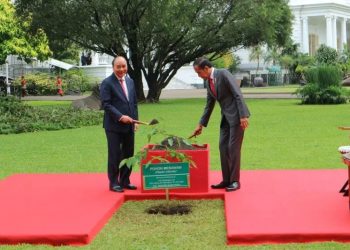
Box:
left=100, top=56, right=138, bottom=192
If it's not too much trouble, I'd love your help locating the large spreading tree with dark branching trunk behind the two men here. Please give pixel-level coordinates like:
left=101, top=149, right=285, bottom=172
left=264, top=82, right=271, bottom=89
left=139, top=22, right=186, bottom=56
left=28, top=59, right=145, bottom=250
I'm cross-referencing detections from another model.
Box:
left=16, top=0, right=291, bottom=101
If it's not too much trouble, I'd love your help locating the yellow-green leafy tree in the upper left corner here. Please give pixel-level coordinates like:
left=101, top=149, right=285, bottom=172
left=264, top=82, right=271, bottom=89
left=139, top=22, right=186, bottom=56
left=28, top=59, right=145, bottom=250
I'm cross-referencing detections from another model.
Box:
left=0, top=0, right=50, bottom=64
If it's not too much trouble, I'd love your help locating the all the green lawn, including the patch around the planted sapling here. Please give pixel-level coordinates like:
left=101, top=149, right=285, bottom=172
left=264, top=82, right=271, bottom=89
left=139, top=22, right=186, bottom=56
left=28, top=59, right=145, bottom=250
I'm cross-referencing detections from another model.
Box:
left=0, top=99, right=350, bottom=249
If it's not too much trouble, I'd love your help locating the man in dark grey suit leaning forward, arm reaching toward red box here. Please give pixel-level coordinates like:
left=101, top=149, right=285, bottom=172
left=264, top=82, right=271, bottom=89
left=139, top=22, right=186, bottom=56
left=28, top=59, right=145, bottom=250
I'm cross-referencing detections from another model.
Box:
left=193, top=57, right=250, bottom=191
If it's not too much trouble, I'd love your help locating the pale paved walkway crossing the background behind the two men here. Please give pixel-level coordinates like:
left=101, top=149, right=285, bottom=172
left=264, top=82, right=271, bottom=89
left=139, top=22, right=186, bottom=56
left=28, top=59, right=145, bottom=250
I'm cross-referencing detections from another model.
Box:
left=22, top=89, right=297, bottom=101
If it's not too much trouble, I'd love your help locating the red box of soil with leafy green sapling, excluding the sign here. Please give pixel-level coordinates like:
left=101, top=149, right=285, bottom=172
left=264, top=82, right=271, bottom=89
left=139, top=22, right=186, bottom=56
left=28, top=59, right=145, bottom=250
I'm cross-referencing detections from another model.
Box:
left=120, top=126, right=209, bottom=193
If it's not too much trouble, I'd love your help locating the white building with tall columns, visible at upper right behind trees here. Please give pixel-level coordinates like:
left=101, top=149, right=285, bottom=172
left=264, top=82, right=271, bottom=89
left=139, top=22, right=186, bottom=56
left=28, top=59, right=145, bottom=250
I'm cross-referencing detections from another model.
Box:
left=235, top=0, right=350, bottom=78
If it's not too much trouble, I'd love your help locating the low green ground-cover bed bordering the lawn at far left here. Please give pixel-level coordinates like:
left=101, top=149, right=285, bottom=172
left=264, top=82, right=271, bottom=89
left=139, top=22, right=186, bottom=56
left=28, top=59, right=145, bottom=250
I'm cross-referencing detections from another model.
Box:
left=0, top=96, right=102, bottom=134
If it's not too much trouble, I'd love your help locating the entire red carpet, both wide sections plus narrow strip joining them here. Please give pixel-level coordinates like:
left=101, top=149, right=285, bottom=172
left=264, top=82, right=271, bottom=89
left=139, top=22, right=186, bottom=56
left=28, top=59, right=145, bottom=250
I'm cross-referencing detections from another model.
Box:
left=0, top=170, right=350, bottom=245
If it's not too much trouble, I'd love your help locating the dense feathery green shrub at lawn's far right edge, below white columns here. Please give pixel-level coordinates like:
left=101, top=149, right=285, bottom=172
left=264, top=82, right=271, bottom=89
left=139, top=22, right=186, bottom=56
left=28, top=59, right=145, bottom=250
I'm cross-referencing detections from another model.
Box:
left=296, top=65, right=348, bottom=104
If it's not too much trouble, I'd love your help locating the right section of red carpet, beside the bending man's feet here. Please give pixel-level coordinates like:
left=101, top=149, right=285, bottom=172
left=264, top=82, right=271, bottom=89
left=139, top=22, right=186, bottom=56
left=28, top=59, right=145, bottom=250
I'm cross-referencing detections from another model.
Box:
left=225, top=170, right=350, bottom=244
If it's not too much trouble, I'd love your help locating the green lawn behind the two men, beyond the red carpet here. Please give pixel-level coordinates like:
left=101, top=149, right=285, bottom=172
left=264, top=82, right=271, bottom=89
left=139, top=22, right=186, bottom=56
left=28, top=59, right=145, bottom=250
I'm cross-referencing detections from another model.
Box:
left=0, top=99, right=350, bottom=178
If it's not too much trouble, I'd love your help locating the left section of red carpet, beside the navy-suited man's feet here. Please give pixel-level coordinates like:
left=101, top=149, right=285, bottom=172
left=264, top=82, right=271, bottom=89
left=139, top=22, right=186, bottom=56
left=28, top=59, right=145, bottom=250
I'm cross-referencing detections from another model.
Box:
left=0, top=174, right=124, bottom=245
